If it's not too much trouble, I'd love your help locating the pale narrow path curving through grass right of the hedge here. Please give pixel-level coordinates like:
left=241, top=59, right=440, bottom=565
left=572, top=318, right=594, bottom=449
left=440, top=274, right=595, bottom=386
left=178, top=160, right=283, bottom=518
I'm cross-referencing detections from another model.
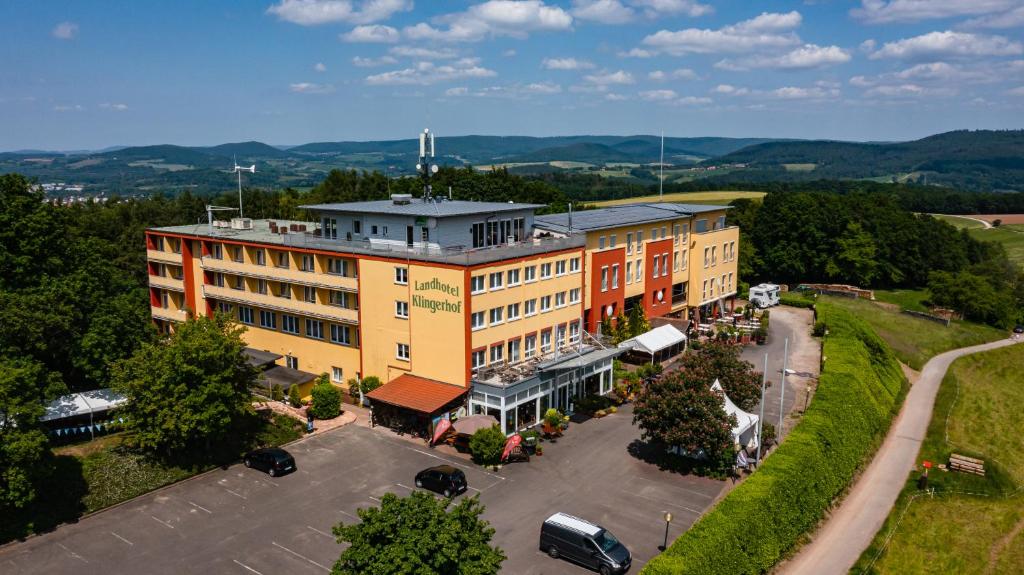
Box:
left=781, top=340, right=1016, bottom=575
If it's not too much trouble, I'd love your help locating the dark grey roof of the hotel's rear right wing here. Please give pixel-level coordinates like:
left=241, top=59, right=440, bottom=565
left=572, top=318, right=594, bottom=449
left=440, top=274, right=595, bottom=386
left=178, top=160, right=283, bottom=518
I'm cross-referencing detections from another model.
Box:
left=534, top=202, right=730, bottom=232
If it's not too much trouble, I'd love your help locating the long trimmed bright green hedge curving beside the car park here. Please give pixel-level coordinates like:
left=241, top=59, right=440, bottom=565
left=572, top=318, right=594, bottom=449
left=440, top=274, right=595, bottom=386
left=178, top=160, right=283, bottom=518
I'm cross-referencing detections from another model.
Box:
left=643, top=303, right=906, bottom=575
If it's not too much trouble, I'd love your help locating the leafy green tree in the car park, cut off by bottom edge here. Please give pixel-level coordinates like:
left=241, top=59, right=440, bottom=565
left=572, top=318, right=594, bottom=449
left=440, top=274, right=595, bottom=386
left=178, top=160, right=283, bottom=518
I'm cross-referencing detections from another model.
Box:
left=331, top=491, right=506, bottom=575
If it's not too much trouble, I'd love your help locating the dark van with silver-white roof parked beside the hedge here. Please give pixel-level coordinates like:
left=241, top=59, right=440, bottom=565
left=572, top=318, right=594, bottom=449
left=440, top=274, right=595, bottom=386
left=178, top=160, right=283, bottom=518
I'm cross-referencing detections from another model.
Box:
left=541, top=513, right=633, bottom=575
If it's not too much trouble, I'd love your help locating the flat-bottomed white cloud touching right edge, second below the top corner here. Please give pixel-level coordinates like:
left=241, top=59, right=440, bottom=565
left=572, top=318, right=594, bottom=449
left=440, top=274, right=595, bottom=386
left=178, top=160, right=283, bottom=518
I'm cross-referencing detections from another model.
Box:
left=869, top=30, right=1024, bottom=59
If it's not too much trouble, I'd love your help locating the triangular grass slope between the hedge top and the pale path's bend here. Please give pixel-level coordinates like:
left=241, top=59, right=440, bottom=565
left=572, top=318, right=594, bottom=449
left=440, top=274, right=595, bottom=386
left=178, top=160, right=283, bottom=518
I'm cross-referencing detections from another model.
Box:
left=822, top=296, right=1008, bottom=369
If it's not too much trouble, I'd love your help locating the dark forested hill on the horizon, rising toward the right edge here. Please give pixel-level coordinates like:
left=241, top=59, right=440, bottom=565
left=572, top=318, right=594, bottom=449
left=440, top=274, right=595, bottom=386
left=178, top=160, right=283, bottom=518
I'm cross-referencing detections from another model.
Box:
left=707, top=130, right=1024, bottom=191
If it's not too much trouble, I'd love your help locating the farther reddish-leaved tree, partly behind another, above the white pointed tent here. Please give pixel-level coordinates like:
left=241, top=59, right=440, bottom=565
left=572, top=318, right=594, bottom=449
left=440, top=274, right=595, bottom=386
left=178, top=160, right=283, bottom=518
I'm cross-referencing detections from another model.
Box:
left=678, top=341, right=762, bottom=411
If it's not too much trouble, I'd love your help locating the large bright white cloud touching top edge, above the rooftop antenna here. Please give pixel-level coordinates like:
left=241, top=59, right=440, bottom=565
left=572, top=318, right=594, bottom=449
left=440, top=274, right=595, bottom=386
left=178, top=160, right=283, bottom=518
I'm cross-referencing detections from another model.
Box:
left=402, top=0, right=572, bottom=42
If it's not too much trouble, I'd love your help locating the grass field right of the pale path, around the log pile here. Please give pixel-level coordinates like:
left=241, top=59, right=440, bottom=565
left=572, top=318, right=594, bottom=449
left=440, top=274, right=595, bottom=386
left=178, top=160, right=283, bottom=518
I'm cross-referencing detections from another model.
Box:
left=851, top=345, right=1024, bottom=574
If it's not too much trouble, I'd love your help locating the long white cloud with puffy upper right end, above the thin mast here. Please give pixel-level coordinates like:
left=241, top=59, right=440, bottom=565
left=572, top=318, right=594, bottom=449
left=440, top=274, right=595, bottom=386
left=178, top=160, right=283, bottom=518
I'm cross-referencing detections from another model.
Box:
left=643, top=11, right=803, bottom=55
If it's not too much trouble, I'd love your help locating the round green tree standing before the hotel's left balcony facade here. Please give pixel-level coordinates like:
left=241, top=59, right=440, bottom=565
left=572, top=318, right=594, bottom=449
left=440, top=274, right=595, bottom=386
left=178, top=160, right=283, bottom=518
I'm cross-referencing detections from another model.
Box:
left=113, top=314, right=257, bottom=456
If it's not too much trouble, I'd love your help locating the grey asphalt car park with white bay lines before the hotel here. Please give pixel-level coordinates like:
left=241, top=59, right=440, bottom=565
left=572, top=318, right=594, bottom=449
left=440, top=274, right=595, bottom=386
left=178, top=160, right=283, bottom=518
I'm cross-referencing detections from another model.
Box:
left=0, top=403, right=724, bottom=575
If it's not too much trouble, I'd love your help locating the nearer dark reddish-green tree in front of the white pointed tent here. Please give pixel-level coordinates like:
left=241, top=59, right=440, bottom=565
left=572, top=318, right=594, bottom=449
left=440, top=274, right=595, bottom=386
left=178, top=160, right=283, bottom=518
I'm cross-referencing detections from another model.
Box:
left=633, top=369, right=736, bottom=462
